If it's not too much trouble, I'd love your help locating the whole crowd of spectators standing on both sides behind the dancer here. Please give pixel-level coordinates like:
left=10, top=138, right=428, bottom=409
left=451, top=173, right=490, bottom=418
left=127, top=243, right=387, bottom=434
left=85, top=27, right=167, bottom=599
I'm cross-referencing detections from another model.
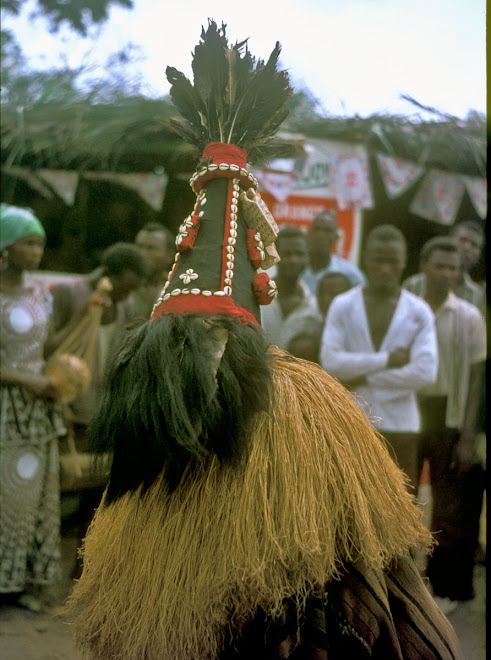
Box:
left=0, top=205, right=486, bottom=624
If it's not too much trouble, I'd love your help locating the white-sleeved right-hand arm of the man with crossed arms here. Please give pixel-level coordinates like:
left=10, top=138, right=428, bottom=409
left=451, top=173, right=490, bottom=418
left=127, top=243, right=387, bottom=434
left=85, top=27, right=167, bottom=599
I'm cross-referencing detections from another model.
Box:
left=367, top=309, right=438, bottom=390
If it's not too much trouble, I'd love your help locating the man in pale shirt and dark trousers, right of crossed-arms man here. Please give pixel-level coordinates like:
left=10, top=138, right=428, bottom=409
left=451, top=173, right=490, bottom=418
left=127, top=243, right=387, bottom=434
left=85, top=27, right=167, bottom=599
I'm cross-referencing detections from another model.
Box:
left=419, top=237, right=486, bottom=614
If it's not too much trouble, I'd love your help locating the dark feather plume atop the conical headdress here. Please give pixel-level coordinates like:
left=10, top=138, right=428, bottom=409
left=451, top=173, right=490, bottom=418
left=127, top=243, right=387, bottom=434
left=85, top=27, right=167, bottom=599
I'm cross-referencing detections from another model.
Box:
left=166, top=20, right=292, bottom=162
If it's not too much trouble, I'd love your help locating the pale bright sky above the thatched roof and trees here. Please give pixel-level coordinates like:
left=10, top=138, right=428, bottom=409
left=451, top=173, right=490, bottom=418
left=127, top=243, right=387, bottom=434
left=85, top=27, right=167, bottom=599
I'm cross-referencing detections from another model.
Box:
left=3, top=0, right=486, bottom=118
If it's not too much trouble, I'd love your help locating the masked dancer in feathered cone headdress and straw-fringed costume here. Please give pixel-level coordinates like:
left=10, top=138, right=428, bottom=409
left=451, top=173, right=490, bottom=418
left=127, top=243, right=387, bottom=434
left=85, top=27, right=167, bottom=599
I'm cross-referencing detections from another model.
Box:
left=65, top=21, right=461, bottom=660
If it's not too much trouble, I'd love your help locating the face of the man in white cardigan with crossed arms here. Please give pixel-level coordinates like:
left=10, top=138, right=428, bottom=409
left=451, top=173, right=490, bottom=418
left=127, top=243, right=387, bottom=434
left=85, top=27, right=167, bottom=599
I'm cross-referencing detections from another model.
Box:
left=363, top=240, right=406, bottom=293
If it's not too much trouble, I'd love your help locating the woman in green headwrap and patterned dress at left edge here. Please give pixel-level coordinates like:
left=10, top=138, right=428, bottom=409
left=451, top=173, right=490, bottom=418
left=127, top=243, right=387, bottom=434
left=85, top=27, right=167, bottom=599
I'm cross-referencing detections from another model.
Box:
left=0, top=204, right=65, bottom=611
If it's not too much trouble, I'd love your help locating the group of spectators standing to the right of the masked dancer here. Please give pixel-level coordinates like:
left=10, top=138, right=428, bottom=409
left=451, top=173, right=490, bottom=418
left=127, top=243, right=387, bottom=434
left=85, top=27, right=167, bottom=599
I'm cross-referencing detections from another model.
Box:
left=263, top=211, right=486, bottom=614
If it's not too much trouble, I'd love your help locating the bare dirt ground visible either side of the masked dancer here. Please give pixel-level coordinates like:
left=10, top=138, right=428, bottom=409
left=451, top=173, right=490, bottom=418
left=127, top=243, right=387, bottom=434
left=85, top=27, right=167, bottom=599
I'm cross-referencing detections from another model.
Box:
left=0, top=494, right=486, bottom=660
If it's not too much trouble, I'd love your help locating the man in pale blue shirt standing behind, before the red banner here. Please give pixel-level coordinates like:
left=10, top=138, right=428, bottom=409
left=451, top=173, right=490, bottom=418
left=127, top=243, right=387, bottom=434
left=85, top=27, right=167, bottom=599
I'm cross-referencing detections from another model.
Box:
left=300, top=209, right=365, bottom=296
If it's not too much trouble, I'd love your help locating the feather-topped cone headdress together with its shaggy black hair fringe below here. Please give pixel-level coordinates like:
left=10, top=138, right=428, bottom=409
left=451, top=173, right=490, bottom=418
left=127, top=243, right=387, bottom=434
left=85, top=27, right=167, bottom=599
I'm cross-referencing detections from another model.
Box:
left=89, top=21, right=291, bottom=503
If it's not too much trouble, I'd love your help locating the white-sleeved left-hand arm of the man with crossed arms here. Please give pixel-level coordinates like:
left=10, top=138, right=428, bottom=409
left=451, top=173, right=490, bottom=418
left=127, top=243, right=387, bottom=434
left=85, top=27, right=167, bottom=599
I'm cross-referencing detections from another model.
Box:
left=320, top=298, right=389, bottom=384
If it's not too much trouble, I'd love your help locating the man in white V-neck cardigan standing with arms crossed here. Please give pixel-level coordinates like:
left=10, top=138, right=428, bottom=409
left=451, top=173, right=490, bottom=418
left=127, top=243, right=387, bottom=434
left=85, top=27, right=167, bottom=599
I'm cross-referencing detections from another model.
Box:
left=321, top=225, right=438, bottom=489
